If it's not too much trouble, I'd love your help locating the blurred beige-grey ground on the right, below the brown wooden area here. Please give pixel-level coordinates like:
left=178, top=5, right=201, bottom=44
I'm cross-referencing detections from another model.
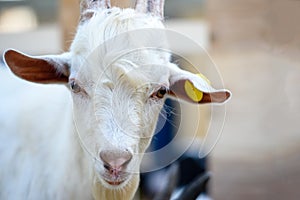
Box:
left=211, top=44, right=300, bottom=200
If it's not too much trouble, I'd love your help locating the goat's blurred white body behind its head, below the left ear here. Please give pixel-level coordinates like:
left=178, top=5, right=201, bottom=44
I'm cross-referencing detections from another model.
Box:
left=0, top=70, right=91, bottom=200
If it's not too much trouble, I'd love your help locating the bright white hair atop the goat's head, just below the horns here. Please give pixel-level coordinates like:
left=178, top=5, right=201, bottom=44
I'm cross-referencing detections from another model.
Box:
left=74, top=8, right=164, bottom=49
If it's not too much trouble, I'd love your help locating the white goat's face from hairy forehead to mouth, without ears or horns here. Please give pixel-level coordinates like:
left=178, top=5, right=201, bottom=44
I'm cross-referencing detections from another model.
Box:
left=69, top=8, right=177, bottom=187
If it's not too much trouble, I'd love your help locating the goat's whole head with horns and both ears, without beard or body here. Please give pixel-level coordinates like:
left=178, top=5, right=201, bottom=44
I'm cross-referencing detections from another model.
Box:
left=4, top=1, right=230, bottom=194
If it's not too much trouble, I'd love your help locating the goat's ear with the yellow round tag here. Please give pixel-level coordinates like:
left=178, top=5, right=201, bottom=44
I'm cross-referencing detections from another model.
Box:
left=169, top=70, right=231, bottom=104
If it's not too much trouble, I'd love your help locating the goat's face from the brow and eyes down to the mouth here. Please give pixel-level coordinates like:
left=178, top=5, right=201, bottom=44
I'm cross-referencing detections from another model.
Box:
left=71, top=57, right=169, bottom=187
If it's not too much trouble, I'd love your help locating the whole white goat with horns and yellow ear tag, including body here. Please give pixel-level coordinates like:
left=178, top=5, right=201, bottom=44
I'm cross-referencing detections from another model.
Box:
left=0, top=0, right=231, bottom=200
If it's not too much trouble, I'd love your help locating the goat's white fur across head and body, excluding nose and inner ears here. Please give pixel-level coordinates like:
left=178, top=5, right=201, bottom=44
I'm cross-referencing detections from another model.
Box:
left=0, top=8, right=231, bottom=200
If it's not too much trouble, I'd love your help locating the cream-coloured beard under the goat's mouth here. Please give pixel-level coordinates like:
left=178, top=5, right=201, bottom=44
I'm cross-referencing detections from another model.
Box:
left=93, top=174, right=140, bottom=200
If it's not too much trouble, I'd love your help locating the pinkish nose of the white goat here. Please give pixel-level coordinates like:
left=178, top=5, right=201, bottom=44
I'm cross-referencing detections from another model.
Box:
left=100, top=150, right=132, bottom=171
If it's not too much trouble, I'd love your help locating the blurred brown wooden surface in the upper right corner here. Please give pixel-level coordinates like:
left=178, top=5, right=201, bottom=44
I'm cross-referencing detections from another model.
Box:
left=207, top=0, right=300, bottom=50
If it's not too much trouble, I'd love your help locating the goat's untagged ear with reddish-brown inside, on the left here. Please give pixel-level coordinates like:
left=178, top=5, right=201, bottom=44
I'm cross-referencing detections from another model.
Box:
left=4, top=49, right=70, bottom=84
